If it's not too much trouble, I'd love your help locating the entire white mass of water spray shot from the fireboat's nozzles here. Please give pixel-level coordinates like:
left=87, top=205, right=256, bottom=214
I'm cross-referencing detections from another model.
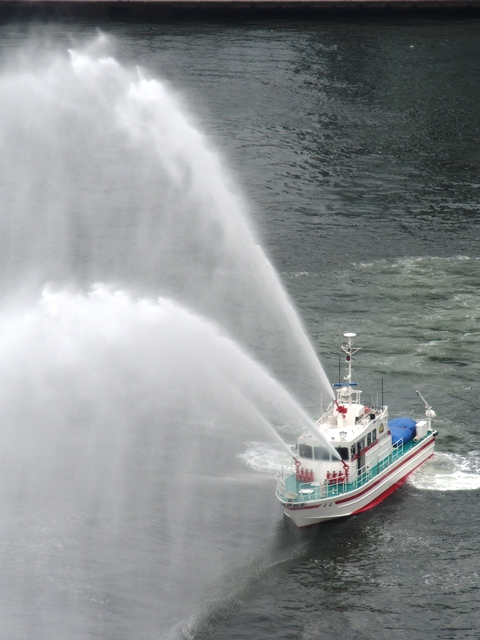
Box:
left=0, top=37, right=331, bottom=640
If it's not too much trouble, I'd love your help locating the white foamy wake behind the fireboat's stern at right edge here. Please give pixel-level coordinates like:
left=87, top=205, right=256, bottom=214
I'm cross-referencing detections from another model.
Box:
left=409, top=451, right=480, bottom=491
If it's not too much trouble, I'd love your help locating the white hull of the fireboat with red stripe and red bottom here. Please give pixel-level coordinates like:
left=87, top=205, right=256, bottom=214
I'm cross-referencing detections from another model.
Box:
left=283, top=433, right=436, bottom=527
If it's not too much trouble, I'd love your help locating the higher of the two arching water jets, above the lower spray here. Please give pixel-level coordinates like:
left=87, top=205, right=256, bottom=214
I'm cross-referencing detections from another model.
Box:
left=0, top=33, right=331, bottom=400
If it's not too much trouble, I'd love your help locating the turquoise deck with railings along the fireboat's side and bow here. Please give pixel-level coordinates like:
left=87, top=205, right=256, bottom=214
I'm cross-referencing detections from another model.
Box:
left=277, top=433, right=431, bottom=506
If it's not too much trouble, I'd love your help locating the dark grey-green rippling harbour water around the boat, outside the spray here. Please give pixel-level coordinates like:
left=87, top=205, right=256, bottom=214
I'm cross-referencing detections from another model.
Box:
left=1, top=15, right=480, bottom=640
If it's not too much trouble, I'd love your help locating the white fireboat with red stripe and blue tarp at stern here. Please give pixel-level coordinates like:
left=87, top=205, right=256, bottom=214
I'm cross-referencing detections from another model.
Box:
left=276, top=333, right=438, bottom=527
